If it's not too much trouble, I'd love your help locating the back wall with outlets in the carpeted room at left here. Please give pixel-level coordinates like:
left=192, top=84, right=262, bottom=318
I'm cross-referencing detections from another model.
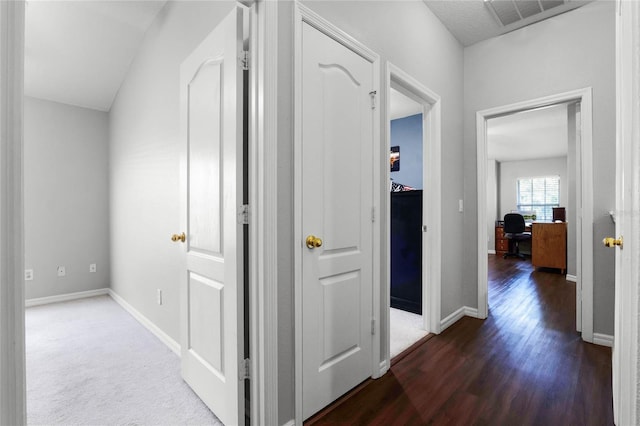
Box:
left=24, top=97, right=110, bottom=299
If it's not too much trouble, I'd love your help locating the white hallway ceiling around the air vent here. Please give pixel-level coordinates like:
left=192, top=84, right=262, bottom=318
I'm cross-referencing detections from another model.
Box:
left=423, top=0, right=592, bottom=46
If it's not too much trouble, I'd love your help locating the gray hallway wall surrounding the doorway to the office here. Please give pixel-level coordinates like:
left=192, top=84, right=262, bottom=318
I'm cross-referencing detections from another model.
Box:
left=464, top=2, right=615, bottom=334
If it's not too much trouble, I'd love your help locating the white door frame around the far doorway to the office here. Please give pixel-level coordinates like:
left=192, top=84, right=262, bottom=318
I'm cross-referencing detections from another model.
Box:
left=476, top=87, right=593, bottom=343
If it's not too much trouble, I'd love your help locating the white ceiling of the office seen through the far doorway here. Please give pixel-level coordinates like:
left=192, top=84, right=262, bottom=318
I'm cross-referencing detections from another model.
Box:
left=487, top=104, right=568, bottom=161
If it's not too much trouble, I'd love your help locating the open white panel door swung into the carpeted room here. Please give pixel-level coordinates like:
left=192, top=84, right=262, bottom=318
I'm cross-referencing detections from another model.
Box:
left=180, top=7, right=245, bottom=425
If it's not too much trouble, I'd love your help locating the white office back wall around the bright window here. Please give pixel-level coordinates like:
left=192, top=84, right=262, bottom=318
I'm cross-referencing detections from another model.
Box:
left=494, top=157, right=569, bottom=220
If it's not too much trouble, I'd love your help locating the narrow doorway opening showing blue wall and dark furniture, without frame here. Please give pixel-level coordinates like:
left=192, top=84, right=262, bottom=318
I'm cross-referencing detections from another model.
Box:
left=388, top=82, right=428, bottom=359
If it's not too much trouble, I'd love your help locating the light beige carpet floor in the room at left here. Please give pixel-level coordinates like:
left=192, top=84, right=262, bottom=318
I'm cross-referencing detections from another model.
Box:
left=26, top=296, right=221, bottom=425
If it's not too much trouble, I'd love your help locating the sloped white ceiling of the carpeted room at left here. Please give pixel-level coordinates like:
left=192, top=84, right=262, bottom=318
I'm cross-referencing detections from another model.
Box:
left=25, top=0, right=166, bottom=111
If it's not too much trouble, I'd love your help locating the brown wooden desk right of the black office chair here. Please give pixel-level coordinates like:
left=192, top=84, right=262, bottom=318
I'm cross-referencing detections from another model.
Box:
left=531, top=222, right=567, bottom=274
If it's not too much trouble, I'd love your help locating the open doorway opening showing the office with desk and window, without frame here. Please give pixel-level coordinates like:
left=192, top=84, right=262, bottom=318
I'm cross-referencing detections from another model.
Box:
left=486, top=102, right=580, bottom=330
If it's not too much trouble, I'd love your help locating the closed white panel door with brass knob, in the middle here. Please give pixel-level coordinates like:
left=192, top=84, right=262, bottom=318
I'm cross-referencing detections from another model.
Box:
left=300, top=23, right=374, bottom=418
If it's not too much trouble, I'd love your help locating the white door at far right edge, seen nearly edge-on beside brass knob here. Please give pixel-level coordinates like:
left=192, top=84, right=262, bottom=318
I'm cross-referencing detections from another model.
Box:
left=612, top=1, right=640, bottom=425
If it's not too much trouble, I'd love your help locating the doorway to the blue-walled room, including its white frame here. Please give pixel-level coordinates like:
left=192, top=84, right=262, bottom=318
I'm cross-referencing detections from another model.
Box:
left=381, top=63, right=441, bottom=368
